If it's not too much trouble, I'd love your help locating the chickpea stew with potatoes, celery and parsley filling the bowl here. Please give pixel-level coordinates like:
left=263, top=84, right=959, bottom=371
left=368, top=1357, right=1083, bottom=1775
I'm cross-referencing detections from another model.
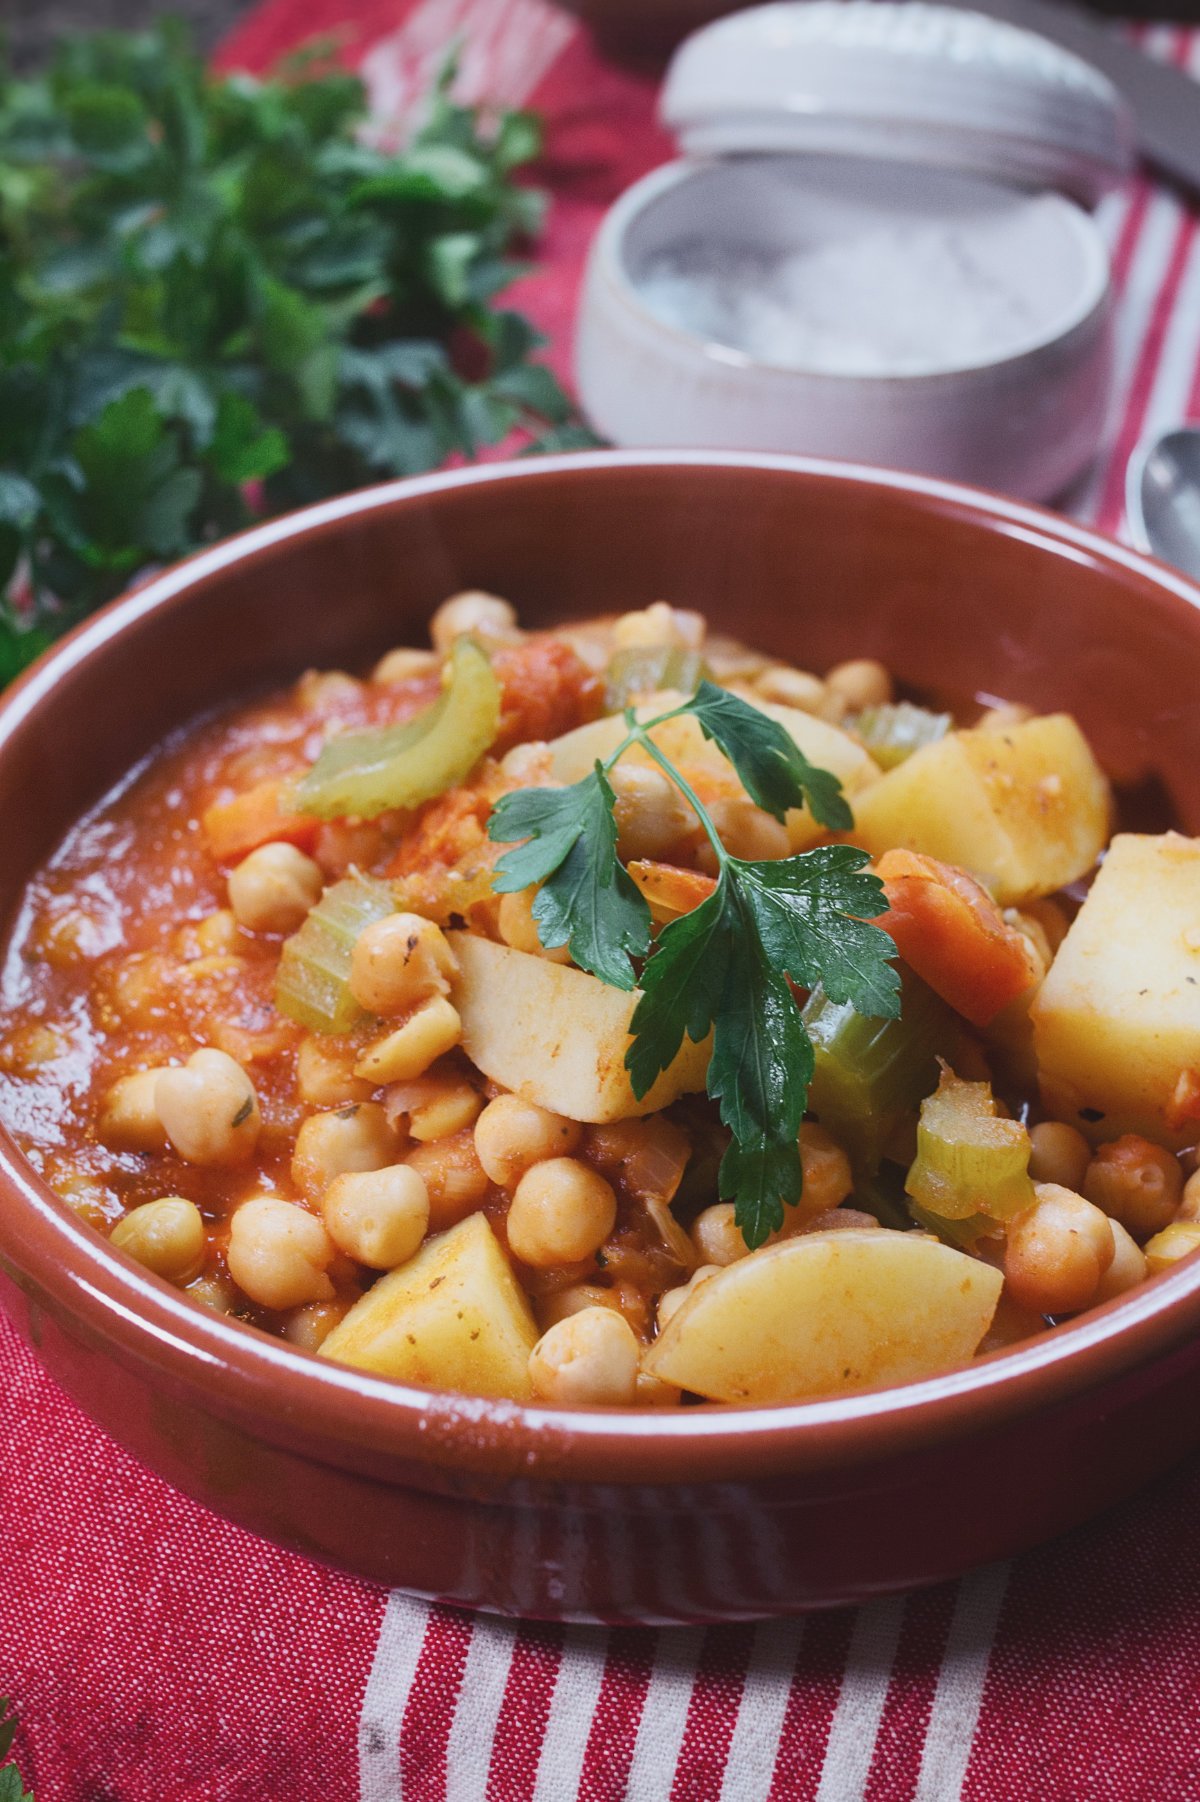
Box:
left=0, top=593, right=1200, bottom=1407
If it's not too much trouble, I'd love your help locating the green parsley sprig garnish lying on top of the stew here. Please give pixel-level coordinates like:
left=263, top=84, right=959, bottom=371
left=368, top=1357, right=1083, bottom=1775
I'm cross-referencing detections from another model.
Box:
left=488, top=681, right=899, bottom=1247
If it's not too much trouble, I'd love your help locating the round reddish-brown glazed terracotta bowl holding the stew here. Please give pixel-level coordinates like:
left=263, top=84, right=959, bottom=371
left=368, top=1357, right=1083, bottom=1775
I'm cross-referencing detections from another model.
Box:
left=0, top=452, right=1200, bottom=1620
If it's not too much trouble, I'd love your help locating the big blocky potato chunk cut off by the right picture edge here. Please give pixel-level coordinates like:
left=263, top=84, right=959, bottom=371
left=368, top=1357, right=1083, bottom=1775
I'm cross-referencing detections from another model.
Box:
left=1031, top=833, right=1200, bottom=1150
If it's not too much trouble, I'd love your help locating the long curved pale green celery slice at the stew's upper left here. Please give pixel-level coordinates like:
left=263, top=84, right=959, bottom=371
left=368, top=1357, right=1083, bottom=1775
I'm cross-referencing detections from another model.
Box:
left=288, top=638, right=501, bottom=820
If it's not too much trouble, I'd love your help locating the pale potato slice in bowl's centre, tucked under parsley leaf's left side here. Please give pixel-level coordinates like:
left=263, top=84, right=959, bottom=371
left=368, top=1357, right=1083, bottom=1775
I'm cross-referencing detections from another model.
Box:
left=447, top=932, right=710, bottom=1123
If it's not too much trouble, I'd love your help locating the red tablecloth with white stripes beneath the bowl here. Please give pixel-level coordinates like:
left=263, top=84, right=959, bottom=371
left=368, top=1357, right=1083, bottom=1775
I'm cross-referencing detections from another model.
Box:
left=0, top=0, right=1200, bottom=1802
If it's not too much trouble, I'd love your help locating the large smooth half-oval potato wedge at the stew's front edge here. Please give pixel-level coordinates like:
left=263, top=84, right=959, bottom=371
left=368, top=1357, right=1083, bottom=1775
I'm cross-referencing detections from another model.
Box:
left=643, top=1227, right=1004, bottom=1402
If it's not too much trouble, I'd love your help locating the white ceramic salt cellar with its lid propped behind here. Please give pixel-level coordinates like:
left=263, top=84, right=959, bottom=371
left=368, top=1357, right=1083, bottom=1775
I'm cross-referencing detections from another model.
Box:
left=577, top=0, right=1132, bottom=499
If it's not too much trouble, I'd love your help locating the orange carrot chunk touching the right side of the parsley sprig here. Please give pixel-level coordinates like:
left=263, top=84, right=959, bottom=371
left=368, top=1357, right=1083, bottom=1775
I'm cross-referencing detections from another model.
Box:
left=876, top=851, right=1041, bottom=1025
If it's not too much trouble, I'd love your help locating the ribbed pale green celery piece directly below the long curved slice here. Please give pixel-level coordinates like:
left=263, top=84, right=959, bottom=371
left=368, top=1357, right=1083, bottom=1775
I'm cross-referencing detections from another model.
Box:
left=276, top=870, right=396, bottom=1033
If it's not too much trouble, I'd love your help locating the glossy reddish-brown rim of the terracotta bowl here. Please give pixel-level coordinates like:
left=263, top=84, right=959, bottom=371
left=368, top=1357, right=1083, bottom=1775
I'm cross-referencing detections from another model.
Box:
left=0, top=451, right=1200, bottom=1488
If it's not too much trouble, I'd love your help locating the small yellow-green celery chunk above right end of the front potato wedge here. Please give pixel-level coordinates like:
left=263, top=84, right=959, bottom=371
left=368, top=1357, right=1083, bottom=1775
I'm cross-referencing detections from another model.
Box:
left=905, top=1070, right=1034, bottom=1220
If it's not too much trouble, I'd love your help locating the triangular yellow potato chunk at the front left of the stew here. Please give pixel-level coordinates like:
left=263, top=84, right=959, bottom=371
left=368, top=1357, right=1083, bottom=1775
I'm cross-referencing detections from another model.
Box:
left=319, top=1215, right=537, bottom=1402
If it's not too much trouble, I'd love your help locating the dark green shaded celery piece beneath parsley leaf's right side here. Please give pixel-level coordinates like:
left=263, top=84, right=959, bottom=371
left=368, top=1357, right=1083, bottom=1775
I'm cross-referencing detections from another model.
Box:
left=804, top=969, right=959, bottom=1177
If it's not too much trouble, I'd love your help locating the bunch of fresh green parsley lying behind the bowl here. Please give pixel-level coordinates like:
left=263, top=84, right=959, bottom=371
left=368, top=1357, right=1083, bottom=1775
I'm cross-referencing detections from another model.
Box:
left=0, top=25, right=573, bottom=679
